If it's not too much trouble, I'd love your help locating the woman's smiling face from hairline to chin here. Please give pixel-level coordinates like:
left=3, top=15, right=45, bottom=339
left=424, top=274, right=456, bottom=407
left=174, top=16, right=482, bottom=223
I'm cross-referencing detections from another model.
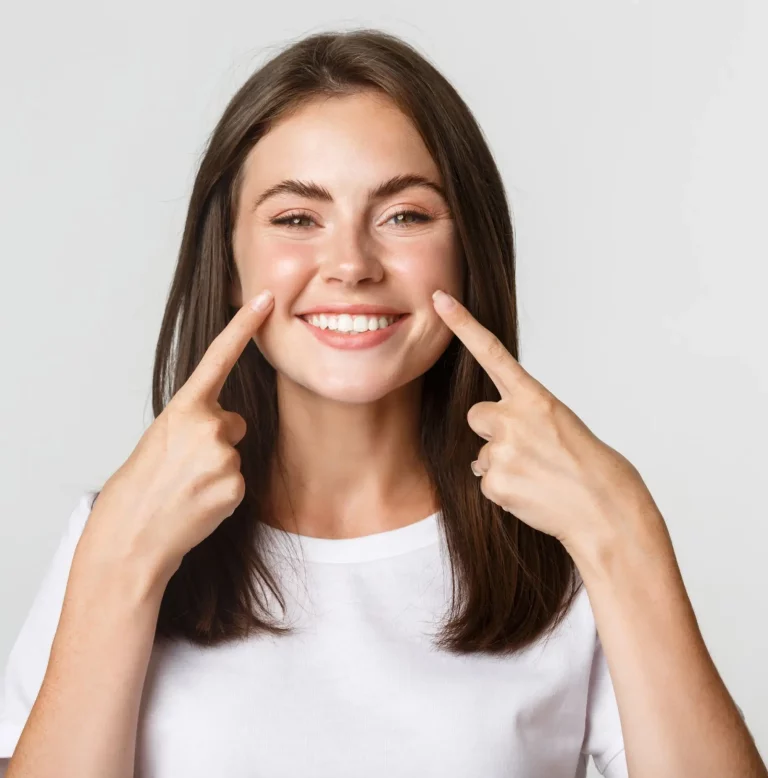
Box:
left=232, top=93, right=462, bottom=403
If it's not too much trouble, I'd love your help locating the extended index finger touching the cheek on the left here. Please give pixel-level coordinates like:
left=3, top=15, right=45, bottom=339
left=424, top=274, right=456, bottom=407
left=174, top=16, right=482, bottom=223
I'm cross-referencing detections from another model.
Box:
left=177, top=289, right=274, bottom=402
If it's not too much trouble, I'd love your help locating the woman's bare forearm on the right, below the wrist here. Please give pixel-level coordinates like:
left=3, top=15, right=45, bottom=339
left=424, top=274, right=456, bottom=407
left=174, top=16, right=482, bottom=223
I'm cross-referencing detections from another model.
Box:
left=573, top=507, right=768, bottom=778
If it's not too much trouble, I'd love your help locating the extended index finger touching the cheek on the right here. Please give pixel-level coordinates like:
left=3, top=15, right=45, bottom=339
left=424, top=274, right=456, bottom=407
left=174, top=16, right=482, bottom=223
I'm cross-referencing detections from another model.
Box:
left=432, top=289, right=528, bottom=397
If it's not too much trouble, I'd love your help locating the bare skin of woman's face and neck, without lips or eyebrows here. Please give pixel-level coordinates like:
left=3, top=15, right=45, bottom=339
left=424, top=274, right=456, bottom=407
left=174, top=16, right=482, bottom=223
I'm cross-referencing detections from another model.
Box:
left=232, top=93, right=463, bottom=538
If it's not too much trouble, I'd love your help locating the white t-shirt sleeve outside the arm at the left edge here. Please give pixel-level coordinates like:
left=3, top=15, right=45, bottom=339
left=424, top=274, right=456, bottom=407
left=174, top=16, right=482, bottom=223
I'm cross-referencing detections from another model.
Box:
left=0, top=491, right=98, bottom=760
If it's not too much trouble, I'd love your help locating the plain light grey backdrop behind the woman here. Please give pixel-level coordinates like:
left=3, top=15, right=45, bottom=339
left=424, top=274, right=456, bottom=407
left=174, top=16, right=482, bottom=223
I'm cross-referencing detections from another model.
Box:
left=0, top=0, right=768, bottom=768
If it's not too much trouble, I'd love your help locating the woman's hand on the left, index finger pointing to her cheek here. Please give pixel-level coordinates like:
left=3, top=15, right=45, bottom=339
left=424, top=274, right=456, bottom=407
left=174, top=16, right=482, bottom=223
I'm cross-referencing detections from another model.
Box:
left=78, top=292, right=274, bottom=583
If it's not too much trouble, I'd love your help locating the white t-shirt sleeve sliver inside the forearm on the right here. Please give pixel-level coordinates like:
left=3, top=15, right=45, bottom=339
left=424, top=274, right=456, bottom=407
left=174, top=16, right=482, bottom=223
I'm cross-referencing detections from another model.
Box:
left=581, top=635, right=628, bottom=778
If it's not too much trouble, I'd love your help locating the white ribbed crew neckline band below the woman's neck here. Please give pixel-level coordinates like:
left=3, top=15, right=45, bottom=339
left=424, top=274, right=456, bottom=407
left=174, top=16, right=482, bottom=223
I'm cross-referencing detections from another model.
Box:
left=261, top=510, right=440, bottom=563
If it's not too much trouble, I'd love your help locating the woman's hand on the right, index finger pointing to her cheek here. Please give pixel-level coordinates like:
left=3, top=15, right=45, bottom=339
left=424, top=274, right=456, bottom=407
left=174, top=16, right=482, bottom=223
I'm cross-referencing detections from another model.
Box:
left=428, top=292, right=653, bottom=551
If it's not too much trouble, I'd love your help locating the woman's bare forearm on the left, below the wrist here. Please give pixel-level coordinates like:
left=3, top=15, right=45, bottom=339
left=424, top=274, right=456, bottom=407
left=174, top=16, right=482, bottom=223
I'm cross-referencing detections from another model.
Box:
left=7, top=549, right=169, bottom=778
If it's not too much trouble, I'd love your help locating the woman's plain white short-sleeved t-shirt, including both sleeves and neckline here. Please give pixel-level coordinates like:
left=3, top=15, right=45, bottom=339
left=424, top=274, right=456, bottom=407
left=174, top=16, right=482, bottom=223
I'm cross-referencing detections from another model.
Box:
left=0, top=491, right=627, bottom=778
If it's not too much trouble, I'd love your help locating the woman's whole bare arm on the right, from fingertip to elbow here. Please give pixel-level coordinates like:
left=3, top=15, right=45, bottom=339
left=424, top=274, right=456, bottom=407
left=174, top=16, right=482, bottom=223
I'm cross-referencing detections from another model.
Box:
left=428, top=295, right=768, bottom=778
